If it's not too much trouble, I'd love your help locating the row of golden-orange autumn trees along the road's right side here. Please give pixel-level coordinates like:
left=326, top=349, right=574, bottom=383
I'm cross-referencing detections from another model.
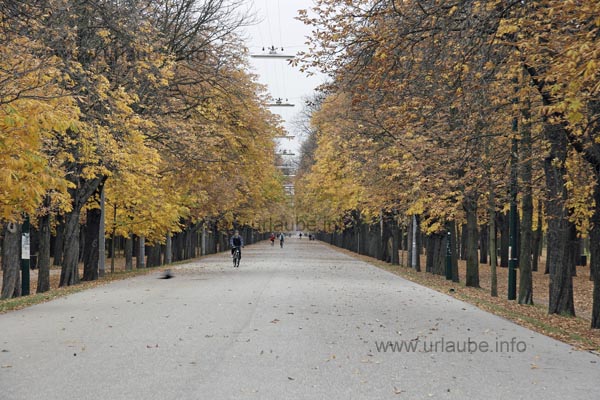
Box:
left=297, top=0, right=600, bottom=328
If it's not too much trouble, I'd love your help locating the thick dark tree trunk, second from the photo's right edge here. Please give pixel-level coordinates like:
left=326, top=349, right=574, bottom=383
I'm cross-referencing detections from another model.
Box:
left=544, top=125, right=575, bottom=316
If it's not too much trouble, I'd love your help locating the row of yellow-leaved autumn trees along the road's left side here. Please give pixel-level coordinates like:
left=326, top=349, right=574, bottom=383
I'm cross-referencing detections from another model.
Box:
left=0, top=0, right=283, bottom=298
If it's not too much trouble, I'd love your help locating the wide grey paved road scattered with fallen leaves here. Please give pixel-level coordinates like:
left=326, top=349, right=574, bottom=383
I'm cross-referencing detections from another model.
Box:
left=0, top=239, right=600, bottom=400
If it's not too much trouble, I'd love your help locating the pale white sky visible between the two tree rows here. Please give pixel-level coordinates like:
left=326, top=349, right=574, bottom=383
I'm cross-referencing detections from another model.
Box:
left=240, top=0, right=323, bottom=153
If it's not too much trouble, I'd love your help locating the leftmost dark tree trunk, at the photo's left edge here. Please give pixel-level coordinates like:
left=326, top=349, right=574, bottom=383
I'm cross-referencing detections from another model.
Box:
left=0, top=223, right=21, bottom=299
